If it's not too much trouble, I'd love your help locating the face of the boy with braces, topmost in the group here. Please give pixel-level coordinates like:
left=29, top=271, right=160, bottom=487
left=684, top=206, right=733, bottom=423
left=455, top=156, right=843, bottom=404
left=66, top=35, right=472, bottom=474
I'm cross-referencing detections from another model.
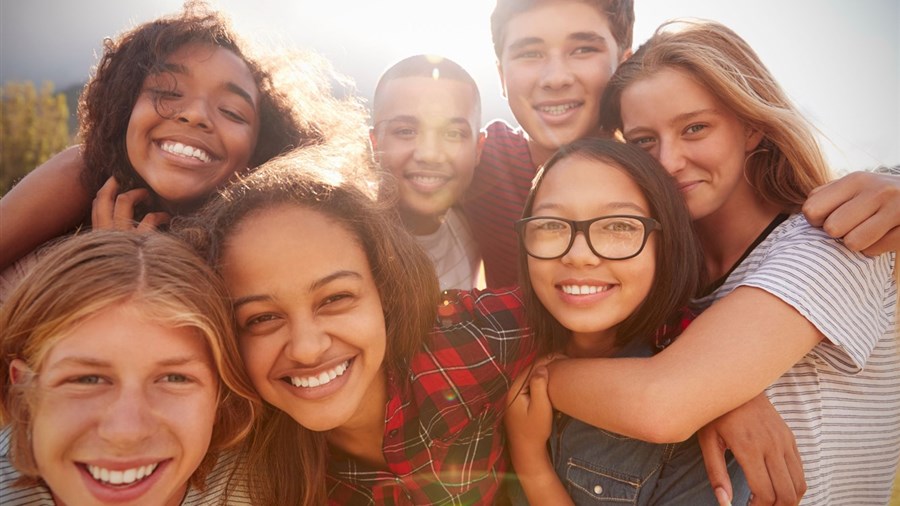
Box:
left=498, top=0, right=627, bottom=154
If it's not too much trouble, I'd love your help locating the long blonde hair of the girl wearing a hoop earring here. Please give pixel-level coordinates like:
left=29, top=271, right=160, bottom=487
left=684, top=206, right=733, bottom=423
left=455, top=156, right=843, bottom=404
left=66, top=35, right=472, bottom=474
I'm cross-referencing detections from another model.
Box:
left=600, top=20, right=831, bottom=212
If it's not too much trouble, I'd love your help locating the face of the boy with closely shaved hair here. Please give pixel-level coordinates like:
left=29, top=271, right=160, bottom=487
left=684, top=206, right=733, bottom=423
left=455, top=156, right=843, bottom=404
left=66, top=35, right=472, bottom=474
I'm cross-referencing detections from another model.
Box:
left=370, top=77, right=484, bottom=229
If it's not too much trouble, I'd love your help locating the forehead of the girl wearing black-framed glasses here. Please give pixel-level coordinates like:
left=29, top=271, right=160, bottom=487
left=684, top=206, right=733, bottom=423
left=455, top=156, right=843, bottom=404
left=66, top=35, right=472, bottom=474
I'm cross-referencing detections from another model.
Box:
left=534, top=155, right=649, bottom=212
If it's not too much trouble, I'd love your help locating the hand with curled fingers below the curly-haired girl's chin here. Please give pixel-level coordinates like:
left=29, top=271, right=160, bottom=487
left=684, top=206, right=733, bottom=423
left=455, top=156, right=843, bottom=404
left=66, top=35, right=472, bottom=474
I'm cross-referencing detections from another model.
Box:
left=91, top=177, right=171, bottom=232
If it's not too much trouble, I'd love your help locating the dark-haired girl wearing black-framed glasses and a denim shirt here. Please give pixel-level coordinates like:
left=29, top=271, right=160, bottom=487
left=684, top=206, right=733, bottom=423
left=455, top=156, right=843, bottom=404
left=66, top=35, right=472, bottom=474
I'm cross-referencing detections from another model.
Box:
left=506, top=139, right=746, bottom=504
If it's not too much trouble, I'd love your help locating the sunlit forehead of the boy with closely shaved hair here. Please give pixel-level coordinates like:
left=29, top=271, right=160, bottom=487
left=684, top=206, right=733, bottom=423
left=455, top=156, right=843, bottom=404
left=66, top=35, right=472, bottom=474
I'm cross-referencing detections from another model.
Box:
left=373, top=76, right=480, bottom=127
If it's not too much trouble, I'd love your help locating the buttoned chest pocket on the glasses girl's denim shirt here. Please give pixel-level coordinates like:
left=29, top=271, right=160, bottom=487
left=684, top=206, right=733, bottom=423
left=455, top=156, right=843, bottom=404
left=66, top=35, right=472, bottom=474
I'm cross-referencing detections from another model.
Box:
left=566, top=458, right=642, bottom=505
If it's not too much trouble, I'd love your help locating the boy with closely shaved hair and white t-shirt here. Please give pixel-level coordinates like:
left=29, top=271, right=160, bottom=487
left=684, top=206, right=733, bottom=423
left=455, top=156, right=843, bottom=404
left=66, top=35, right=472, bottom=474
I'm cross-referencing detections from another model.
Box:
left=370, top=55, right=485, bottom=290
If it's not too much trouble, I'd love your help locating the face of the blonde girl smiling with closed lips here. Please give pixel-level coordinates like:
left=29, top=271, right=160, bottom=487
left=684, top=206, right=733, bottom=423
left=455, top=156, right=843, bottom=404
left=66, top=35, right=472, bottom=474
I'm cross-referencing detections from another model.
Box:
left=621, top=68, right=760, bottom=220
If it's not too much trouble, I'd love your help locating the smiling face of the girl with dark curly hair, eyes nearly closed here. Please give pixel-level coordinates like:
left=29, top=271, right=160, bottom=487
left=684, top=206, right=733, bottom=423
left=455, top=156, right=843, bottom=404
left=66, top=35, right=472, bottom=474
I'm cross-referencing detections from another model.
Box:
left=125, top=44, right=260, bottom=211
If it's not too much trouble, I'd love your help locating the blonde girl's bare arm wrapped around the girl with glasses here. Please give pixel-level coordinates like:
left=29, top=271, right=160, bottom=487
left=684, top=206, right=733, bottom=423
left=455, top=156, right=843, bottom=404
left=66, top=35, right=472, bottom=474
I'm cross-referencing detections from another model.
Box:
left=548, top=287, right=823, bottom=443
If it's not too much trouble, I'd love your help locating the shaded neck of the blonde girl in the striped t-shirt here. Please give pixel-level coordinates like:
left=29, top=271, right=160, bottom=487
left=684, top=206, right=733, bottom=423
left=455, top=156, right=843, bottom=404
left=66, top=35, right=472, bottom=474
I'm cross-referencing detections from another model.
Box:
left=694, top=195, right=781, bottom=281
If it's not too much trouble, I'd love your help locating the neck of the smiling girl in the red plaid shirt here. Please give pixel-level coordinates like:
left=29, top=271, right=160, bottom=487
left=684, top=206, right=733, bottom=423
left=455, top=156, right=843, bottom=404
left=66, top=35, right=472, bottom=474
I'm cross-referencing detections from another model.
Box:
left=325, top=372, right=388, bottom=469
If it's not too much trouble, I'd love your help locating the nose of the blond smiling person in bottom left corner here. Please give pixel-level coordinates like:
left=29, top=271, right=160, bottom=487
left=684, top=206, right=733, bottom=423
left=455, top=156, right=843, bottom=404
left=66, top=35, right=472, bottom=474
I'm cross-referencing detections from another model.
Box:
left=97, top=386, right=159, bottom=448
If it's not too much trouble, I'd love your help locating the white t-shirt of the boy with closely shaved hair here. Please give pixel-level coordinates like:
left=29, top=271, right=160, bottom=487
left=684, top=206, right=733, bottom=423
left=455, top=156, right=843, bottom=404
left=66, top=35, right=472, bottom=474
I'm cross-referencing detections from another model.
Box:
left=413, top=208, right=481, bottom=290
